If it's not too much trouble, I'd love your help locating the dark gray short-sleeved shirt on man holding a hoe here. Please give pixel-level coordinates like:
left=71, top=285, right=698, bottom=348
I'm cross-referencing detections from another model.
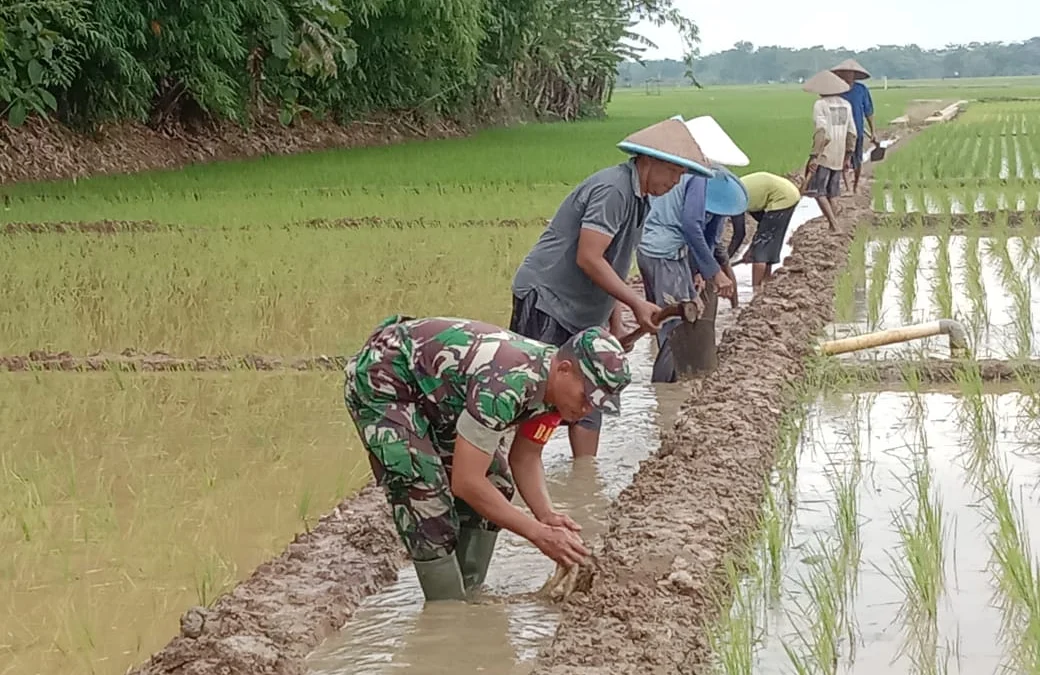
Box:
left=513, top=159, right=650, bottom=333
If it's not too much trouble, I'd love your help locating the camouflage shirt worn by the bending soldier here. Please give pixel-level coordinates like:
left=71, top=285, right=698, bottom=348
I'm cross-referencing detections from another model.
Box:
left=357, top=316, right=556, bottom=455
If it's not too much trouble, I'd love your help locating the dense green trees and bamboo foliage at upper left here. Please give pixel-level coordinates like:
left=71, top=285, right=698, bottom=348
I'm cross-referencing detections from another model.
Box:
left=0, top=0, right=696, bottom=126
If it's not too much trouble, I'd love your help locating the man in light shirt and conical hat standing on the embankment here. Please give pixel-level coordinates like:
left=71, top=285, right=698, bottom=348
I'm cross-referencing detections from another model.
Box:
left=803, top=71, right=857, bottom=230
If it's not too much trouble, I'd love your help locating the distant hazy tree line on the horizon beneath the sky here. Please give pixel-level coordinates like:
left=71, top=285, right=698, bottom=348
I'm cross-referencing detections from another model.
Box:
left=618, top=37, right=1040, bottom=86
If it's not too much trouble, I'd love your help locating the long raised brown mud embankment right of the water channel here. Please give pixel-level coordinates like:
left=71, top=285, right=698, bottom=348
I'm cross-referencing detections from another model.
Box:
left=535, top=213, right=870, bottom=675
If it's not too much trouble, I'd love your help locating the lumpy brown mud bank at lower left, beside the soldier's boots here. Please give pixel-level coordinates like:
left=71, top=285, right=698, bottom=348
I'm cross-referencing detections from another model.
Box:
left=131, top=485, right=405, bottom=675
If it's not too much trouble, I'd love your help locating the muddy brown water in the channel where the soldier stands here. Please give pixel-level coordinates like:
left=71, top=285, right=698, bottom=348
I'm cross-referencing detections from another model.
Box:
left=308, top=338, right=684, bottom=675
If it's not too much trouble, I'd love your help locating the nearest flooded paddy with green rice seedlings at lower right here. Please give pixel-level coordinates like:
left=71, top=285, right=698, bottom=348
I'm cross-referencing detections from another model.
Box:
left=717, top=381, right=1040, bottom=673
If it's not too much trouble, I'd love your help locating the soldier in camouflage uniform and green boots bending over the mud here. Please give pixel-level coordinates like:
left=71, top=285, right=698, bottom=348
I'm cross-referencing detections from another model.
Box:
left=344, top=315, right=631, bottom=600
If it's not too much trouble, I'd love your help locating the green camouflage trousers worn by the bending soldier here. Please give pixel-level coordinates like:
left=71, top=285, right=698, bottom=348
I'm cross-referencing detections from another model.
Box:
left=344, top=322, right=515, bottom=561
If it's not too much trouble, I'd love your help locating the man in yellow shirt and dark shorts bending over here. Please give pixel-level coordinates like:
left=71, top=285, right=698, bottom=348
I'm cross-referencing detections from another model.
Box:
left=730, top=172, right=802, bottom=292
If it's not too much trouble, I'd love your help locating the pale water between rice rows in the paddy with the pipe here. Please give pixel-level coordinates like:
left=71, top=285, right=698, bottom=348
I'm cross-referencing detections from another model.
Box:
left=829, top=229, right=1040, bottom=359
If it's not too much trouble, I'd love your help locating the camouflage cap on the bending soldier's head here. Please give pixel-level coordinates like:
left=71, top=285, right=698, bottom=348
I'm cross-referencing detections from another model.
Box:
left=564, top=327, right=632, bottom=414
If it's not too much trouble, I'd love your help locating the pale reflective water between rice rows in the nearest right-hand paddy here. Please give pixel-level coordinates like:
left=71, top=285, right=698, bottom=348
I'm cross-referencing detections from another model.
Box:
left=755, top=392, right=1040, bottom=674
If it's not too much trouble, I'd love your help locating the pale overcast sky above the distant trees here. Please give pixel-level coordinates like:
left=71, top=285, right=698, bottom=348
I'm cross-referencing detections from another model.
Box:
left=639, top=0, right=1040, bottom=58
